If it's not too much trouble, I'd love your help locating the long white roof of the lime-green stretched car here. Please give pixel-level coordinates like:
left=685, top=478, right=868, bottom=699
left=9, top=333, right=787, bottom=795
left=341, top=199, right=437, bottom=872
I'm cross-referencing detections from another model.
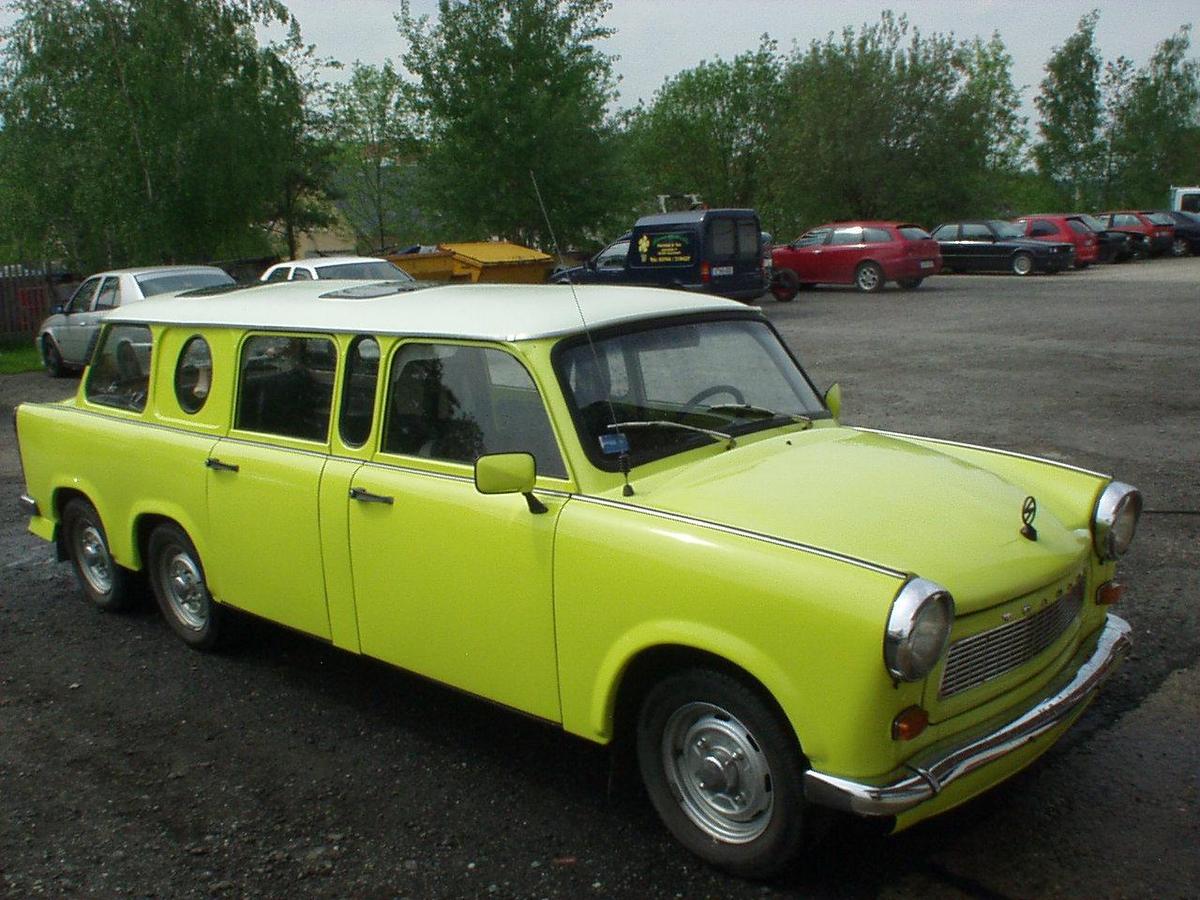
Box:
left=108, top=281, right=748, bottom=341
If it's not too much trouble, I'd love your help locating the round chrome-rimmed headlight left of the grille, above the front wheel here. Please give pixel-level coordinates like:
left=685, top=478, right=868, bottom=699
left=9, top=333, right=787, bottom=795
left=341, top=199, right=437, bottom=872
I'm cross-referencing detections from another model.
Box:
left=883, top=578, right=954, bottom=682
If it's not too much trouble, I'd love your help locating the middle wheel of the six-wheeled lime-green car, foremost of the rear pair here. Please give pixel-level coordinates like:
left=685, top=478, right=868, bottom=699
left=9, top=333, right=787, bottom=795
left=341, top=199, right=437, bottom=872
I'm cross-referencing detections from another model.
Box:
left=146, top=522, right=223, bottom=650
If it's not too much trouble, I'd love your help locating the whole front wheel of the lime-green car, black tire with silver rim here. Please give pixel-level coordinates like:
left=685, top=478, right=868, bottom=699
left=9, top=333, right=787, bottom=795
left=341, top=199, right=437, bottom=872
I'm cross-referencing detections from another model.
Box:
left=637, top=668, right=809, bottom=878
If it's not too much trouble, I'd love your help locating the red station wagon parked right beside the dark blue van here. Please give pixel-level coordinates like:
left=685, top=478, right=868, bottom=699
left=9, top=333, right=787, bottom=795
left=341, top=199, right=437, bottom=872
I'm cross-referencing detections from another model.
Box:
left=770, top=222, right=942, bottom=301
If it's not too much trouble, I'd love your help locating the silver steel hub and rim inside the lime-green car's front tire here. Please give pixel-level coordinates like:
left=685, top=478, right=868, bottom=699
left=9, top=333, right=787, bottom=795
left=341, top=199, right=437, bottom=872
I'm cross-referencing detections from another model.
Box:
left=662, top=703, right=775, bottom=844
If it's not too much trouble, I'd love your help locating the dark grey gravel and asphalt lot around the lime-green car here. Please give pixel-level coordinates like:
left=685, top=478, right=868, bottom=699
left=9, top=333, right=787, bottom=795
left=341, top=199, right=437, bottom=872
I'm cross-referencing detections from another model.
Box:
left=0, top=259, right=1200, bottom=898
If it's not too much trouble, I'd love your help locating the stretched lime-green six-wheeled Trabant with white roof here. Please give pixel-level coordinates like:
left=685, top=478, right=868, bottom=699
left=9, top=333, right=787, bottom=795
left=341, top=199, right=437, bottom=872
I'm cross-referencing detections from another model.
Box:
left=16, top=282, right=1141, bottom=876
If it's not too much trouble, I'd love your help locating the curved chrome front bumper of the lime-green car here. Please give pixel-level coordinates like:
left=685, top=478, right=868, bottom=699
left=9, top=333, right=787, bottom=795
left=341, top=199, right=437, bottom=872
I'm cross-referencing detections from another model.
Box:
left=804, top=616, right=1132, bottom=816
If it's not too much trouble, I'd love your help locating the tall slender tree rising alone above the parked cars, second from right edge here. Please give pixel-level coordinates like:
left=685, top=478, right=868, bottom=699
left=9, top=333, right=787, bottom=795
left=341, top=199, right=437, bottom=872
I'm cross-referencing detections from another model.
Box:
left=1033, top=10, right=1104, bottom=209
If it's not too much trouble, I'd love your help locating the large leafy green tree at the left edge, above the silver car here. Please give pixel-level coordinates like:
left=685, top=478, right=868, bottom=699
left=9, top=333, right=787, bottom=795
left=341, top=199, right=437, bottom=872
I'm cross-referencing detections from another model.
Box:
left=0, top=0, right=326, bottom=269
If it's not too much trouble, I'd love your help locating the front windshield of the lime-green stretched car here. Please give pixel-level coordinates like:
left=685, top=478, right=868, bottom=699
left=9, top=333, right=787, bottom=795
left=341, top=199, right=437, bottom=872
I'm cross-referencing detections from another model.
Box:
left=556, top=319, right=827, bottom=470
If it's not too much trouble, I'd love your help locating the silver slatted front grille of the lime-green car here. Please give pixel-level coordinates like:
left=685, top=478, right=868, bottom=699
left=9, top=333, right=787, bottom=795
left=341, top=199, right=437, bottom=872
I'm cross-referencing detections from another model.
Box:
left=938, top=576, right=1084, bottom=700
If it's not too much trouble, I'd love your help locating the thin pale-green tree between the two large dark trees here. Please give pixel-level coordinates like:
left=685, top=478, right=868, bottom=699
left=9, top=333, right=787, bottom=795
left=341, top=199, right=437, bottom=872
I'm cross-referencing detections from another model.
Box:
left=330, top=61, right=420, bottom=252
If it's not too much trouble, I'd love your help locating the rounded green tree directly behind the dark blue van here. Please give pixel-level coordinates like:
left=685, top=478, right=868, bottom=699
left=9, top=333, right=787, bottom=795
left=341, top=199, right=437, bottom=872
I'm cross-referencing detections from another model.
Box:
left=626, top=35, right=784, bottom=214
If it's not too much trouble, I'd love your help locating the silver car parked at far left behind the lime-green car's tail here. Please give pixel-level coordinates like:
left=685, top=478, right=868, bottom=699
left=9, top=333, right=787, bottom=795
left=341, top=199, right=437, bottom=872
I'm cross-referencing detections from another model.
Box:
left=37, top=265, right=234, bottom=378
